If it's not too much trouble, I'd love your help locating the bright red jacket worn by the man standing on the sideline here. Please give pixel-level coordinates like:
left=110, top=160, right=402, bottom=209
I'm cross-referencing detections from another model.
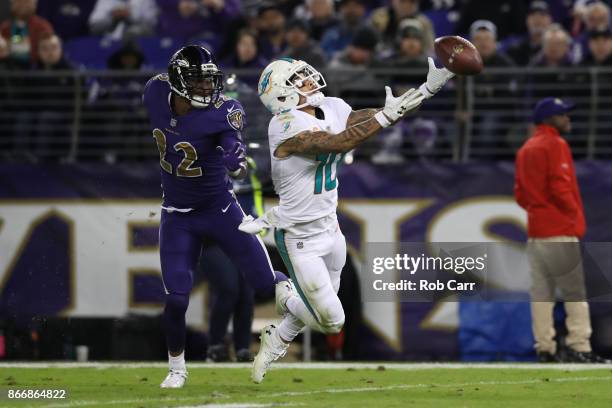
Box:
left=514, top=125, right=586, bottom=238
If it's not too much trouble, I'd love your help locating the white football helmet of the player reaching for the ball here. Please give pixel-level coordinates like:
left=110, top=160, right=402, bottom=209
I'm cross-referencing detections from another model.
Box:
left=257, top=58, right=327, bottom=115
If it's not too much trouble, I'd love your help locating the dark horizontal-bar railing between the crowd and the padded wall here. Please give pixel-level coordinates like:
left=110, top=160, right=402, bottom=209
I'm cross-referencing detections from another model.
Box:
left=0, top=67, right=612, bottom=163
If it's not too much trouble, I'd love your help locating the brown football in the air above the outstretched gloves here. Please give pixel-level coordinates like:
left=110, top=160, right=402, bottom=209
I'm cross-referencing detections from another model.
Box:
left=434, top=35, right=482, bottom=75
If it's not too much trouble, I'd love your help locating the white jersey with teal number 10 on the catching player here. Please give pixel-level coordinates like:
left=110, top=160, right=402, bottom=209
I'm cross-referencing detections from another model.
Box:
left=268, top=97, right=352, bottom=234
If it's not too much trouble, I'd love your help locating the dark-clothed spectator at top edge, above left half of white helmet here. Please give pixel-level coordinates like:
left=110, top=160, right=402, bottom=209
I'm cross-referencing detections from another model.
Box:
left=255, top=2, right=287, bottom=61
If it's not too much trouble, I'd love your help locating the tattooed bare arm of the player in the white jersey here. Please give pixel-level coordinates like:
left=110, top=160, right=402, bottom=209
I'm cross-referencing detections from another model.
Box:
left=275, top=115, right=382, bottom=157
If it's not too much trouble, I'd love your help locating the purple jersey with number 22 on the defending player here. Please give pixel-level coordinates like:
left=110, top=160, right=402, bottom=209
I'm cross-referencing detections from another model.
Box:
left=143, top=74, right=246, bottom=209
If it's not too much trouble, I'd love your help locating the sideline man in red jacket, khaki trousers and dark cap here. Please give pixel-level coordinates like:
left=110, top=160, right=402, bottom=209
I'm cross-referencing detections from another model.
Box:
left=514, top=98, right=605, bottom=362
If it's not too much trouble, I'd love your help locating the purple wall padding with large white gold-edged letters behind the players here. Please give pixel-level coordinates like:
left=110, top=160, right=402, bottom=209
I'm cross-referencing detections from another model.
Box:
left=0, top=161, right=612, bottom=360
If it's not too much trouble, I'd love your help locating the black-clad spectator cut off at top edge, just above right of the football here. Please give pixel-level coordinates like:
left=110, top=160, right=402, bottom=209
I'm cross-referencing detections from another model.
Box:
left=456, top=0, right=527, bottom=40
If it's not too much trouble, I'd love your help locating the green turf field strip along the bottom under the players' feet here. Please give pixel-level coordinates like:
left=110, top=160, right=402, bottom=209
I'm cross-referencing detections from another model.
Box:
left=0, top=363, right=612, bottom=408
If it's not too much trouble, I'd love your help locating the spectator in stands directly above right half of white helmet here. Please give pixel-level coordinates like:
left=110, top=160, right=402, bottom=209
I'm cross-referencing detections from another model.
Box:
left=283, top=18, right=327, bottom=70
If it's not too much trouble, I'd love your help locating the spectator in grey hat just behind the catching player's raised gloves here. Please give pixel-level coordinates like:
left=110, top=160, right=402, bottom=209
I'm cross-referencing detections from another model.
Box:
left=376, top=18, right=428, bottom=87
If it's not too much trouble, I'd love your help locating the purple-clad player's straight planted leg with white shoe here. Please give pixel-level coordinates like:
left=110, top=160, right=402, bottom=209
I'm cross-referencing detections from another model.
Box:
left=159, top=211, right=201, bottom=388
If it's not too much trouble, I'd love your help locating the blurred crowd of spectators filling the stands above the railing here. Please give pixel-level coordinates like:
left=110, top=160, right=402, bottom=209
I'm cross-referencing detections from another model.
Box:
left=0, top=0, right=612, bottom=163
